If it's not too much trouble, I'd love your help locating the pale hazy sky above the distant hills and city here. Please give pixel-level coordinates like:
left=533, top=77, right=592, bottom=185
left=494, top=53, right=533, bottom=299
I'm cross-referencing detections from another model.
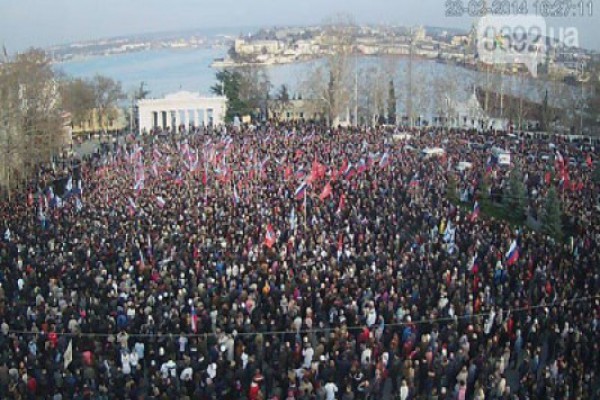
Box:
left=0, top=0, right=600, bottom=53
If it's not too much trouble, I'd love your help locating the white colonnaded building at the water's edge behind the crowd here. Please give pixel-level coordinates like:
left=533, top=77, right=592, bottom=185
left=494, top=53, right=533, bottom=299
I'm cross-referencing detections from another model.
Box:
left=137, top=91, right=227, bottom=133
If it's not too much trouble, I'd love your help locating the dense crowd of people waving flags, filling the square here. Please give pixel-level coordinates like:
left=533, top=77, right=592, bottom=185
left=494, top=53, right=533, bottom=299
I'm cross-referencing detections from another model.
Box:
left=0, top=124, right=600, bottom=400
